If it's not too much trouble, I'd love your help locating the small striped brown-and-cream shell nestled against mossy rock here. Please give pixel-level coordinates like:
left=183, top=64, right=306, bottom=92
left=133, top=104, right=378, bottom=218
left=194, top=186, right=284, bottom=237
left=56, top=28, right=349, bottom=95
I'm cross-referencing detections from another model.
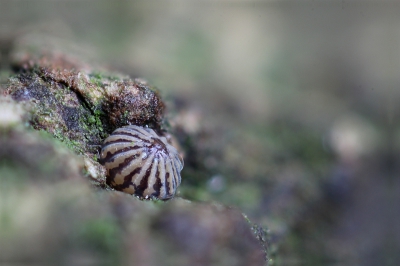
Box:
left=100, top=125, right=183, bottom=200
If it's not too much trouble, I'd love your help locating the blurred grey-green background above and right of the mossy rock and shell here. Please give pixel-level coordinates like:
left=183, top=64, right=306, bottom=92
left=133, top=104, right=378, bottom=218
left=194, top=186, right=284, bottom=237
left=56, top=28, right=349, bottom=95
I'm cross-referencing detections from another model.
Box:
left=0, top=0, right=400, bottom=265
